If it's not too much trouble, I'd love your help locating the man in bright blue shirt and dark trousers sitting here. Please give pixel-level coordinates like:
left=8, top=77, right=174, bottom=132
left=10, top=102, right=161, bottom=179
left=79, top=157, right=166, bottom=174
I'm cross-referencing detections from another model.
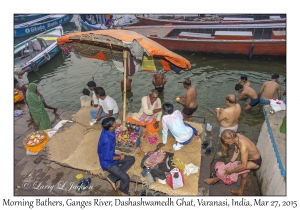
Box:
left=98, top=117, right=135, bottom=196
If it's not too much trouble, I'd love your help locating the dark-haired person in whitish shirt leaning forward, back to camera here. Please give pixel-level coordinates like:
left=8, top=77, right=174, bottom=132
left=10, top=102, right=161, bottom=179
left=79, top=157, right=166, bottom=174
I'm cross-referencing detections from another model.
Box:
left=162, top=103, right=199, bottom=150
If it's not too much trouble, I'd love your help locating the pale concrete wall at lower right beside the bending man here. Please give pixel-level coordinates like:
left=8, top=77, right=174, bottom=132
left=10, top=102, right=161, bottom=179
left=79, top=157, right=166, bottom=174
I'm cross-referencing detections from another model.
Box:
left=256, top=121, right=286, bottom=195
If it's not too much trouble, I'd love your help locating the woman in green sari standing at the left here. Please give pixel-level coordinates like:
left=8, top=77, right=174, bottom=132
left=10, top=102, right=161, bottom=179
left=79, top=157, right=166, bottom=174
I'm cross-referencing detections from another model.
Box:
left=26, top=83, right=52, bottom=130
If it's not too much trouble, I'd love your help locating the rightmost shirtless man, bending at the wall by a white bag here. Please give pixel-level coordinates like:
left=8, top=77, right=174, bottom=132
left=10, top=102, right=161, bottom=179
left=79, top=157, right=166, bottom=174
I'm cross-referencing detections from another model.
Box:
left=259, top=74, right=281, bottom=105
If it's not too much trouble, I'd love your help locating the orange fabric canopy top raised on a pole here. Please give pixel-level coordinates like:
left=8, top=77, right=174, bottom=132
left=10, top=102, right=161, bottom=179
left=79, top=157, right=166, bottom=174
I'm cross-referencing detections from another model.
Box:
left=57, top=29, right=191, bottom=69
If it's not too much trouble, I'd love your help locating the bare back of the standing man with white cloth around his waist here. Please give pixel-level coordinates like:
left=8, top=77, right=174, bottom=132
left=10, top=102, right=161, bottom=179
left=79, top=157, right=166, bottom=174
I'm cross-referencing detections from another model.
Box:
left=219, top=104, right=242, bottom=128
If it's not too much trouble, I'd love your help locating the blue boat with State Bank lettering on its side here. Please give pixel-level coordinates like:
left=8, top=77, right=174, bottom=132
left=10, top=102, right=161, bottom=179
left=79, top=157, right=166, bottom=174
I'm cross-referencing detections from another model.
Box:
left=14, top=14, right=73, bottom=37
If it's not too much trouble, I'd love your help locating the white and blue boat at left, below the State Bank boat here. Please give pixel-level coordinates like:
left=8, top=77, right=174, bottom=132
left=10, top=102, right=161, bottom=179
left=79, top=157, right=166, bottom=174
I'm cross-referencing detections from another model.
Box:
left=14, top=26, right=63, bottom=72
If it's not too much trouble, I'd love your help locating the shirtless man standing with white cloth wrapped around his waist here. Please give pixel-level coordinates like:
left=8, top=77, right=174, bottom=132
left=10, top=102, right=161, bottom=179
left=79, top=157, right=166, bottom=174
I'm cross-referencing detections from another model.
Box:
left=215, top=94, right=242, bottom=157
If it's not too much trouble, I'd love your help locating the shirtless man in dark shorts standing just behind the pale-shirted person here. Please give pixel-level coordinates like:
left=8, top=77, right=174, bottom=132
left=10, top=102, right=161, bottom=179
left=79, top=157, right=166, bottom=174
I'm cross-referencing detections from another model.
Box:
left=176, top=79, right=198, bottom=121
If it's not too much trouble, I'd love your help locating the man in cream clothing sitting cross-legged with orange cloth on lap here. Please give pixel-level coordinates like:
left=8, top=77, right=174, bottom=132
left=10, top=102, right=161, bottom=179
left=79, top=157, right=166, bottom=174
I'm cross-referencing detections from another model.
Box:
left=126, top=89, right=162, bottom=134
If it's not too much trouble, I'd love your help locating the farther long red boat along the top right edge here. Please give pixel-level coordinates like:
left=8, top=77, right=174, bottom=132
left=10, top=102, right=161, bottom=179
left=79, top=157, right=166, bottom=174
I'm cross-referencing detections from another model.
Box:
left=137, top=15, right=286, bottom=25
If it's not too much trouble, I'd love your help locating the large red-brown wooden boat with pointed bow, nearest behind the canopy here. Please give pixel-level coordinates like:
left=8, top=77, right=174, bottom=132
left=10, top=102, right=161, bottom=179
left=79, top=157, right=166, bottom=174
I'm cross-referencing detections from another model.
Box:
left=124, top=23, right=286, bottom=57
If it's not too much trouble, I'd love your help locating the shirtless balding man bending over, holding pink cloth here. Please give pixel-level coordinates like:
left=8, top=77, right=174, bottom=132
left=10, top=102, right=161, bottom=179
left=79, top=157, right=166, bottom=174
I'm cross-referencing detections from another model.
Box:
left=204, top=129, right=262, bottom=195
